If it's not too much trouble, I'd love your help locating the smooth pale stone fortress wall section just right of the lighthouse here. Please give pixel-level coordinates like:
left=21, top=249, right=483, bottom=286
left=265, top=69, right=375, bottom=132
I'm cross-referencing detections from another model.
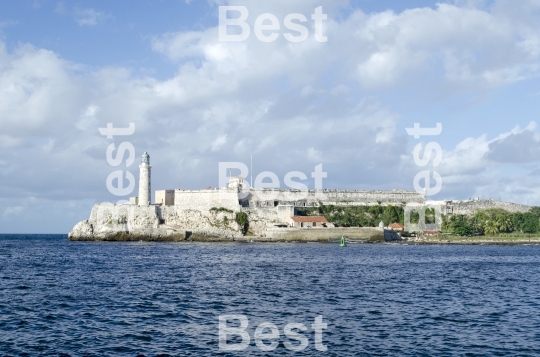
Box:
left=174, top=189, right=240, bottom=212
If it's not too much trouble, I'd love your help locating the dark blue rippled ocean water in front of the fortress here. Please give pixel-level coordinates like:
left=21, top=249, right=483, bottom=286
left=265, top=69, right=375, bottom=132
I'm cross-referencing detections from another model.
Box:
left=0, top=235, right=540, bottom=357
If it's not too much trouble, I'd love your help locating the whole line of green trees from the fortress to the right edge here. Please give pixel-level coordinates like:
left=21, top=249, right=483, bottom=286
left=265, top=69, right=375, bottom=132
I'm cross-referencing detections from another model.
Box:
left=297, top=204, right=540, bottom=236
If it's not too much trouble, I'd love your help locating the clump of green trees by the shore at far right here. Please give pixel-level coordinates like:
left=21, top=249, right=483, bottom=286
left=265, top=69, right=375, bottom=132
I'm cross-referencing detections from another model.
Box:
left=442, top=207, right=540, bottom=236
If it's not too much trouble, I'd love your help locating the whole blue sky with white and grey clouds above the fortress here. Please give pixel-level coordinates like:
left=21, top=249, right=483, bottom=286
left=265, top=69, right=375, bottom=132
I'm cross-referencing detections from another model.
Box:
left=0, top=0, right=540, bottom=233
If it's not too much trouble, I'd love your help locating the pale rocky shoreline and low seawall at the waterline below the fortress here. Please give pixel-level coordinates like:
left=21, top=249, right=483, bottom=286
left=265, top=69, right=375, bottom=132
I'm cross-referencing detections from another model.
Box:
left=68, top=203, right=540, bottom=245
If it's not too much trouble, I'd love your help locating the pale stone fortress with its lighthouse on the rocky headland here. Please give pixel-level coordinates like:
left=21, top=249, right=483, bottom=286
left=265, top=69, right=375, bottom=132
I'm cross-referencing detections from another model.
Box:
left=68, top=152, right=530, bottom=241
